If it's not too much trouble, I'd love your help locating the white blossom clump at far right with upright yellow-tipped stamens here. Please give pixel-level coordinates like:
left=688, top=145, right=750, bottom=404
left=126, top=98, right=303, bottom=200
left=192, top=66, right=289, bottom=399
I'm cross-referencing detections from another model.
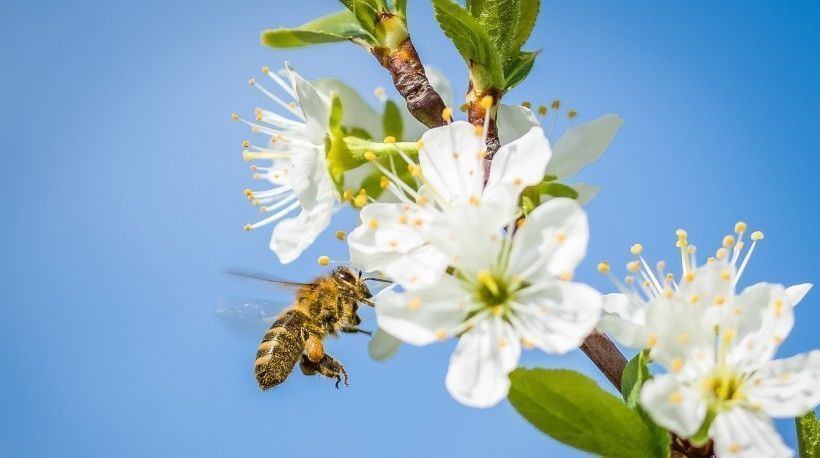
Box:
left=599, top=223, right=820, bottom=457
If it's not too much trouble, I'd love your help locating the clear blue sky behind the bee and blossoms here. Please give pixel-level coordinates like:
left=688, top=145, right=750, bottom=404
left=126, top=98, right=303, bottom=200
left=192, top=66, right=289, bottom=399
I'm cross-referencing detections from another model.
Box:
left=0, top=0, right=820, bottom=457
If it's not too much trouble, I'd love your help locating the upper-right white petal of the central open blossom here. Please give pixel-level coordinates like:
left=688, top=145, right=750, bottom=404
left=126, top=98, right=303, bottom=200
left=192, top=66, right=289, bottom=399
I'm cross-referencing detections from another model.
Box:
left=510, top=198, right=589, bottom=282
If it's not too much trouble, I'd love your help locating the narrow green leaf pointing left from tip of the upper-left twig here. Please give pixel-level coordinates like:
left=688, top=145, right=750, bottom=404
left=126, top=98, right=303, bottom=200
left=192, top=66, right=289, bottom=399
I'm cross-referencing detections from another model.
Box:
left=260, top=10, right=372, bottom=48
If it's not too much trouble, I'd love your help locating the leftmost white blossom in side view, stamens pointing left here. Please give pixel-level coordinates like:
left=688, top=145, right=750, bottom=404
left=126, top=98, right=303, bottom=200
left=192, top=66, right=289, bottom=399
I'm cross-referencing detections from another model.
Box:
left=233, top=66, right=381, bottom=263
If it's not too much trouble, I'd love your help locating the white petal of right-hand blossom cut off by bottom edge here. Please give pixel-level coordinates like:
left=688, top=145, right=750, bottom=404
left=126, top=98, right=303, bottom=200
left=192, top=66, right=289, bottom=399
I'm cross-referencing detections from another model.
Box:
left=709, top=407, right=792, bottom=458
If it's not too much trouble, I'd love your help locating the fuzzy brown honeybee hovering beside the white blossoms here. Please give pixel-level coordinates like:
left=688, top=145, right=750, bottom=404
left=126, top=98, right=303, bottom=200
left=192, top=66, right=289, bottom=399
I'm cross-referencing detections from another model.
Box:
left=223, top=267, right=381, bottom=390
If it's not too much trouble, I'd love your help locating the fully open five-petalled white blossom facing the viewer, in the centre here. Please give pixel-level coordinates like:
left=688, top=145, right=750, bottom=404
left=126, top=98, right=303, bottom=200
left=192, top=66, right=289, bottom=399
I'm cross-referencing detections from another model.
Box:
left=374, top=199, right=601, bottom=407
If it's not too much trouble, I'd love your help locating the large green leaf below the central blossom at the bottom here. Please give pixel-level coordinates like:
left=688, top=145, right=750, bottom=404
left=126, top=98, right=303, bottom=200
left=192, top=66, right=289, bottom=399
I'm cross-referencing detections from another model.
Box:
left=509, top=368, right=657, bottom=457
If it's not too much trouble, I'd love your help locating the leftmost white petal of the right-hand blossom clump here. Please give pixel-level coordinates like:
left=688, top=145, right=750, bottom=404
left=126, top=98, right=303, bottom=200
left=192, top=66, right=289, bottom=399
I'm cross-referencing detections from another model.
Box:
left=598, top=293, right=649, bottom=348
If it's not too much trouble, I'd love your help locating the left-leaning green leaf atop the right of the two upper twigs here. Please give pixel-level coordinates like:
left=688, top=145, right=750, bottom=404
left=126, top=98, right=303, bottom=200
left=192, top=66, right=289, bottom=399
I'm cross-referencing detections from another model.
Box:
left=433, top=0, right=504, bottom=90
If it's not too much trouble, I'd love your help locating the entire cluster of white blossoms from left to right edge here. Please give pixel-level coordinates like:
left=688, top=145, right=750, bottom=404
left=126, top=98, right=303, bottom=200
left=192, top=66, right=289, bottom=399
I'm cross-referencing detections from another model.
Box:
left=234, top=63, right=820, bottom=456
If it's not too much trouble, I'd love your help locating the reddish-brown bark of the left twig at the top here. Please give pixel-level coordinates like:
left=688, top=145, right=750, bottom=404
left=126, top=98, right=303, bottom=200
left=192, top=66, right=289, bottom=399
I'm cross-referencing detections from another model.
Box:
left=373, top=38, right=446, bottom=128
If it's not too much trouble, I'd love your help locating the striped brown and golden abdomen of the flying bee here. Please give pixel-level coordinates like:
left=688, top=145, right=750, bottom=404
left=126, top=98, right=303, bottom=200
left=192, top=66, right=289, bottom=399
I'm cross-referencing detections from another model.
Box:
left=253, top=310, right=309, bottom=390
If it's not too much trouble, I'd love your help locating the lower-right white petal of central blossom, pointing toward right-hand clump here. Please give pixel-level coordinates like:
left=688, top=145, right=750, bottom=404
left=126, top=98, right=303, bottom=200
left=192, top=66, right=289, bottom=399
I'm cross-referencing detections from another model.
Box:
left=509, top=281, right=601, bottom=354
